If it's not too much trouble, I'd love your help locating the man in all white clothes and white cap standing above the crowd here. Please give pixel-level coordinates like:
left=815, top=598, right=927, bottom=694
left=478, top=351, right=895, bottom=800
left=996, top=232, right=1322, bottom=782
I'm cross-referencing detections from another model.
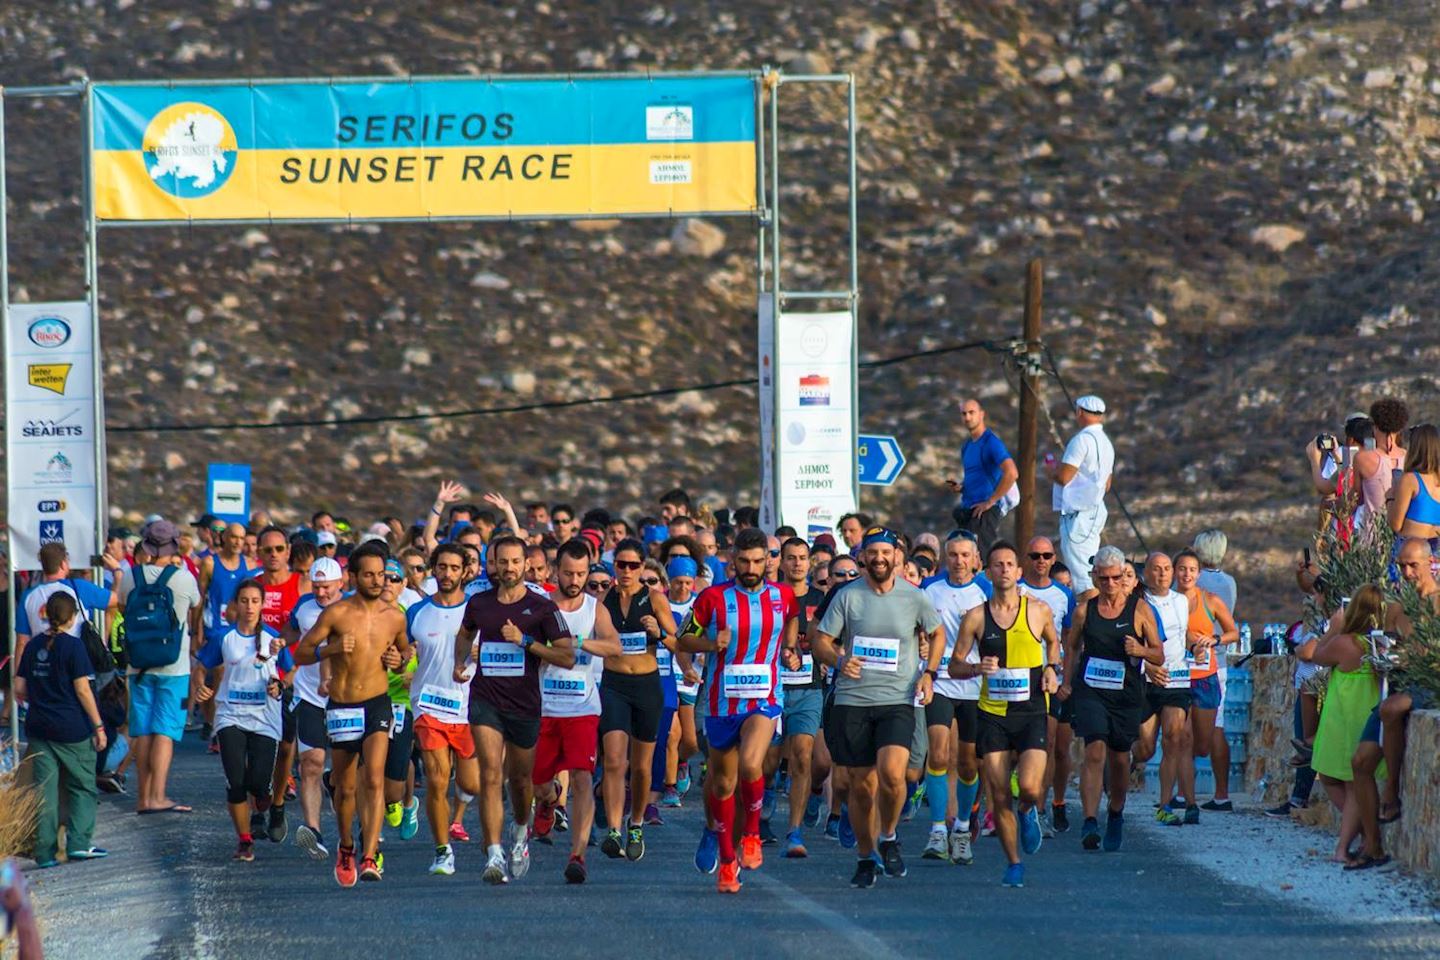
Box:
left=1050, top=394, right=1115, bottom=596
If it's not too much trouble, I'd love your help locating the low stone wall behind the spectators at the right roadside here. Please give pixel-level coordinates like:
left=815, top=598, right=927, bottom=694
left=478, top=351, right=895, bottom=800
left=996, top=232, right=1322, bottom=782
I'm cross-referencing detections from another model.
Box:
left=1246, top=656, right=1440, bottom=878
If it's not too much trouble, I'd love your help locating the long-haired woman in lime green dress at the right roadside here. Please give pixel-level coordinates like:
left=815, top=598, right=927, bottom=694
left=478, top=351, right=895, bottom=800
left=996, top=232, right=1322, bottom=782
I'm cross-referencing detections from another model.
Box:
left=1295, top=584, right=1390, bottom=869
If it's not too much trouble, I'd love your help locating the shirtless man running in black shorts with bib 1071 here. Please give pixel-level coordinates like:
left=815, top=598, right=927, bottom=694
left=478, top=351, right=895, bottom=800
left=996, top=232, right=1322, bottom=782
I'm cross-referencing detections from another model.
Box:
left=295, top=543, right=410, bottom=887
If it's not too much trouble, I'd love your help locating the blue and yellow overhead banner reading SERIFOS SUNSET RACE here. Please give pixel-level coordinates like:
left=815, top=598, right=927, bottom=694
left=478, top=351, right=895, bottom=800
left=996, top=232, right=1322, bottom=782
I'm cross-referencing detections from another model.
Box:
left=91, top=76, right=756, bottom=220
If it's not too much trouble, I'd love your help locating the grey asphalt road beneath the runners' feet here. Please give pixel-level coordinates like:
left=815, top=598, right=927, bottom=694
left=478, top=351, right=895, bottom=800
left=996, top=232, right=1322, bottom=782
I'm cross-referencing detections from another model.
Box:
left=32, top=740, right=1440, bottom=960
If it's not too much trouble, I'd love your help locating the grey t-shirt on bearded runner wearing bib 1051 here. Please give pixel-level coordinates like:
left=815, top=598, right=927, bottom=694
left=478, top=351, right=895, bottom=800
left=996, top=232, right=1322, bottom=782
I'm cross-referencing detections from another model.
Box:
left=819, top=579, right=940, bottom=707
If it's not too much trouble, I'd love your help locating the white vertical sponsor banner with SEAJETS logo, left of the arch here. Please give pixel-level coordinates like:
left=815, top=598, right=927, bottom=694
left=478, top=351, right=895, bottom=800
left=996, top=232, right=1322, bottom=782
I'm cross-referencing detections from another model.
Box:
left=6, top=301, right=96, bottom=570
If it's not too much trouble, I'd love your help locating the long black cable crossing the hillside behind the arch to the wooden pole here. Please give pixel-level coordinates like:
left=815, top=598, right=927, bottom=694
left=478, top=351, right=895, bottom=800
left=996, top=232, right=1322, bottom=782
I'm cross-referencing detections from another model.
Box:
left=105, top=333, right=1008, bottom=433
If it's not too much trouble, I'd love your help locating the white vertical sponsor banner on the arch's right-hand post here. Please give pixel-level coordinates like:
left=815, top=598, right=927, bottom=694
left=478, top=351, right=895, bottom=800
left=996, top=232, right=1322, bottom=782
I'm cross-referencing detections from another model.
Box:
left=775, top=311, right=855, bottom=538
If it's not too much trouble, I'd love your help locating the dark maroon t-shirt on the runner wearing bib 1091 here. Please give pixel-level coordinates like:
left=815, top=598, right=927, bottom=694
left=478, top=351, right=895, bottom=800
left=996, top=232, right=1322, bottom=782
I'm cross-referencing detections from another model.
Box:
left=461, top=587, right=570, bottom=717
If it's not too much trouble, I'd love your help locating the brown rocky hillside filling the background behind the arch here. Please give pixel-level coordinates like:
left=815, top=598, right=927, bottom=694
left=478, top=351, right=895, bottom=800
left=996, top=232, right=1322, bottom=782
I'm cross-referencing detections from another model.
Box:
left=0, top=0, right=1440, bottom=617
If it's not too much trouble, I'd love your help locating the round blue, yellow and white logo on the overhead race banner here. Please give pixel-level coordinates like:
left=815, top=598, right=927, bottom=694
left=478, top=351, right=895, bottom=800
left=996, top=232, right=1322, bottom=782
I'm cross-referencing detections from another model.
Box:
left=141, top=102, right=238, bottom=200
